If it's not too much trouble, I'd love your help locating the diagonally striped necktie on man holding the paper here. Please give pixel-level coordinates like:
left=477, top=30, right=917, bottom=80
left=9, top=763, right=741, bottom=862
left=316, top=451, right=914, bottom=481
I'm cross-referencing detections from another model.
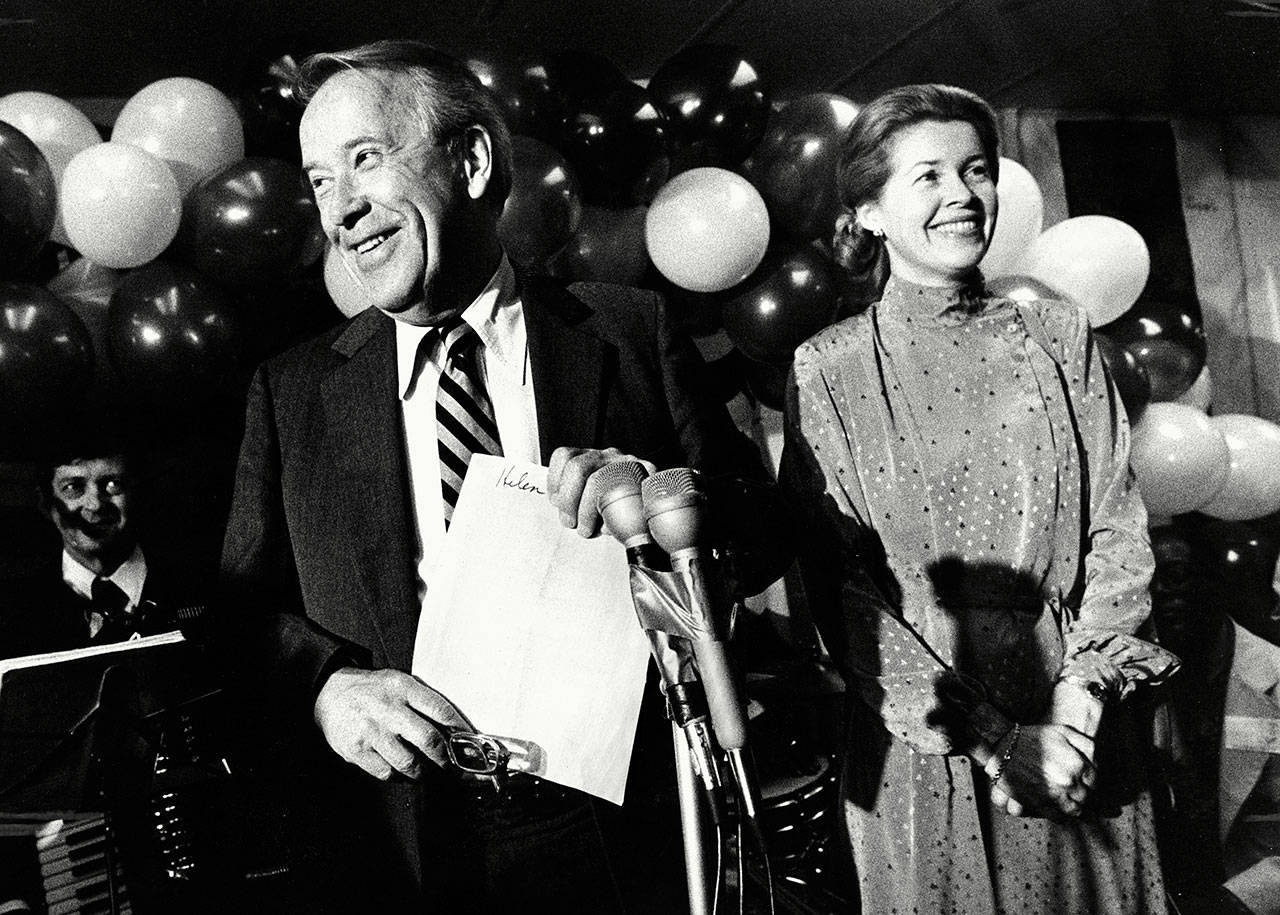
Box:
left=433, top=317, right=502, bottom=527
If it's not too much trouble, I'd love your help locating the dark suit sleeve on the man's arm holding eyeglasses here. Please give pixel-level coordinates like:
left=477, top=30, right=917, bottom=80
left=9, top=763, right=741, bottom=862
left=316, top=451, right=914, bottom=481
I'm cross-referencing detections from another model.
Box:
left=218, top=366, right=360, bottom=720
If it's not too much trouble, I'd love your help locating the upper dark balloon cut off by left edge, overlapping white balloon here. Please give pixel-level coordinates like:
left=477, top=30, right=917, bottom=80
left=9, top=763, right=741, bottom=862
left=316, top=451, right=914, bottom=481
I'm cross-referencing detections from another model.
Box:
left=0, top=122, right=58, bottom=278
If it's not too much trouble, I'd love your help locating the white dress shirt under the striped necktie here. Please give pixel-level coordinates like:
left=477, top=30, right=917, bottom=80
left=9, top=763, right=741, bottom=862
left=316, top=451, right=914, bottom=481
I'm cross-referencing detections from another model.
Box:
left=396, top=255, right=541, bottom=600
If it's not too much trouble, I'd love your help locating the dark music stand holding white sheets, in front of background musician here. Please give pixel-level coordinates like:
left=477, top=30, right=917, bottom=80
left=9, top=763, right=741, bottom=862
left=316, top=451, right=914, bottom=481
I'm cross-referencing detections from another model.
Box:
left=0, top=633, right=202, bottom=914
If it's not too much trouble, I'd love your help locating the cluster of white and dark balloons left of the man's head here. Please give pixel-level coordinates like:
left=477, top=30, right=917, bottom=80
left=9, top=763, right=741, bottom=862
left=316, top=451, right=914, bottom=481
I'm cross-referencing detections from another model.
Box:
left=0, top=71, right=323, bottom=442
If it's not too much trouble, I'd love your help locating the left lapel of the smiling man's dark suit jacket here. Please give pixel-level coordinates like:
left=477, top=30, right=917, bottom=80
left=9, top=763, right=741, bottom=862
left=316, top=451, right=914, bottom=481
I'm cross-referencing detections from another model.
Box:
left=316, top=310, right=417, bottom=669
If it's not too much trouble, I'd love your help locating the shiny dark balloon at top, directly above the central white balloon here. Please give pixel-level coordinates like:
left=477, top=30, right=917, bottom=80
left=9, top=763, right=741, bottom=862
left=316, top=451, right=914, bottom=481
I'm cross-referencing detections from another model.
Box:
left=649, top=45, right=769, bottom=171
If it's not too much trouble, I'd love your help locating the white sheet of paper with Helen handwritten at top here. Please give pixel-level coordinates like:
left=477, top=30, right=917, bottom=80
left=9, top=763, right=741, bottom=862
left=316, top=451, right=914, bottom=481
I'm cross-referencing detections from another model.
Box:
left=413, top=456, right=649, bottom=804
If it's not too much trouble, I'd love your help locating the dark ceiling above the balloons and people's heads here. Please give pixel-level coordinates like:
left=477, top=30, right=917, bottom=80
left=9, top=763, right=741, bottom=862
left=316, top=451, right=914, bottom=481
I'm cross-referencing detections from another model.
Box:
left=0, top=0, right=1280, bottom=114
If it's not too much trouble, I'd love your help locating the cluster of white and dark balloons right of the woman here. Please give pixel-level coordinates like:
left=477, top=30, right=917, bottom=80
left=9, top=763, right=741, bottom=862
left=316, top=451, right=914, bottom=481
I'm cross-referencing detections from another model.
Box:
left=967, top=160, right=1280, bottom=522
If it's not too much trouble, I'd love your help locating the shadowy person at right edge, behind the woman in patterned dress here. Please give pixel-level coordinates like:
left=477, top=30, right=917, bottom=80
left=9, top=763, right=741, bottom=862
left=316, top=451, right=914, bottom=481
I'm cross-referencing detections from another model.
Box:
left=1152, top=527, right=1280, bottom=915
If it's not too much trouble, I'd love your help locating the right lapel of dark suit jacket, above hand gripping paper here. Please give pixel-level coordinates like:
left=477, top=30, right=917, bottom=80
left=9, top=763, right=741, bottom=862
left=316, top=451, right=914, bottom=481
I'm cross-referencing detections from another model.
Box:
left=521, top=280, right=612, bottom=463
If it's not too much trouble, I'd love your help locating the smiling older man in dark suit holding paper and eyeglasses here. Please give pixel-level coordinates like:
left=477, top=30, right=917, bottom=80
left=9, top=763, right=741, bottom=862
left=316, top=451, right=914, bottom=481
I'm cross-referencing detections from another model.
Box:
left=223, top=41, right=760, bottom=912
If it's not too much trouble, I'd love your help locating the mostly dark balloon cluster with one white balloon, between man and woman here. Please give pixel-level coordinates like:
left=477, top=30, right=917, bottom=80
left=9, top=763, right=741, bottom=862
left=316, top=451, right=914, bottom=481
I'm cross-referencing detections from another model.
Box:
left=471, top=44, right=858, bottom=407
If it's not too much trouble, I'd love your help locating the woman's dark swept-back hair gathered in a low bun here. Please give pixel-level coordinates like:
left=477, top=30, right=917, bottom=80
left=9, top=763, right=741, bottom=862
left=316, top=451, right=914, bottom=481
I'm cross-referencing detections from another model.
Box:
left=832, top=83, right=1000, bottom=274
